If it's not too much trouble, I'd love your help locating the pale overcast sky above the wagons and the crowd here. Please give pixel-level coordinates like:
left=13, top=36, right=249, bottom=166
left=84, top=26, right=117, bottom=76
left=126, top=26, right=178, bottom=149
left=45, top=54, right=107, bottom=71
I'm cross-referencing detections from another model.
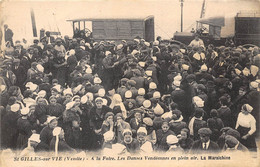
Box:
left=0, top=0, right=260, bottom=39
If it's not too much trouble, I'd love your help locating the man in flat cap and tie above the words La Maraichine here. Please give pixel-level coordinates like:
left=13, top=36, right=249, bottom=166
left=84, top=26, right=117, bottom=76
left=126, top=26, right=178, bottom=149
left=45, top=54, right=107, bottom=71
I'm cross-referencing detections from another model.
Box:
left=190, top=128, right=219, bottom=153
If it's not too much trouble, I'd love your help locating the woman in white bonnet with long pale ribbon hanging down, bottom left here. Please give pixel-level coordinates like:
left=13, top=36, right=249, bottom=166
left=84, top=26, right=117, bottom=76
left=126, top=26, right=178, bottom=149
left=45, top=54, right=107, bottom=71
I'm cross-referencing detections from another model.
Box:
left=50, top=127, right=75, bottom=156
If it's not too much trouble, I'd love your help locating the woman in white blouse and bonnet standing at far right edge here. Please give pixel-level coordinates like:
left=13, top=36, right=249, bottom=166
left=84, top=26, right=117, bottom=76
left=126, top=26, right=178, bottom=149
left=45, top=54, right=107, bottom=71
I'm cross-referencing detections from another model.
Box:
left=235, top=104, right=256, bottom=151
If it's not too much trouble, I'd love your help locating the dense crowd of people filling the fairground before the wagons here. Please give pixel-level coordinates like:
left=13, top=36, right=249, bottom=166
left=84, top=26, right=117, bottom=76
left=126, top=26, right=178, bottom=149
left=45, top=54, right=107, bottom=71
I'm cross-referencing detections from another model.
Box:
left=0, top=26, right=260, bottom=155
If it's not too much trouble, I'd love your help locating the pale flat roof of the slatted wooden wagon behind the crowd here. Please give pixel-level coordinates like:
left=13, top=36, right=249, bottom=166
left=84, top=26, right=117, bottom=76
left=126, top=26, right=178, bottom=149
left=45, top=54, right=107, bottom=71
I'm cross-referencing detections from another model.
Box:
left=67, top=15, right=154, bottom=21
